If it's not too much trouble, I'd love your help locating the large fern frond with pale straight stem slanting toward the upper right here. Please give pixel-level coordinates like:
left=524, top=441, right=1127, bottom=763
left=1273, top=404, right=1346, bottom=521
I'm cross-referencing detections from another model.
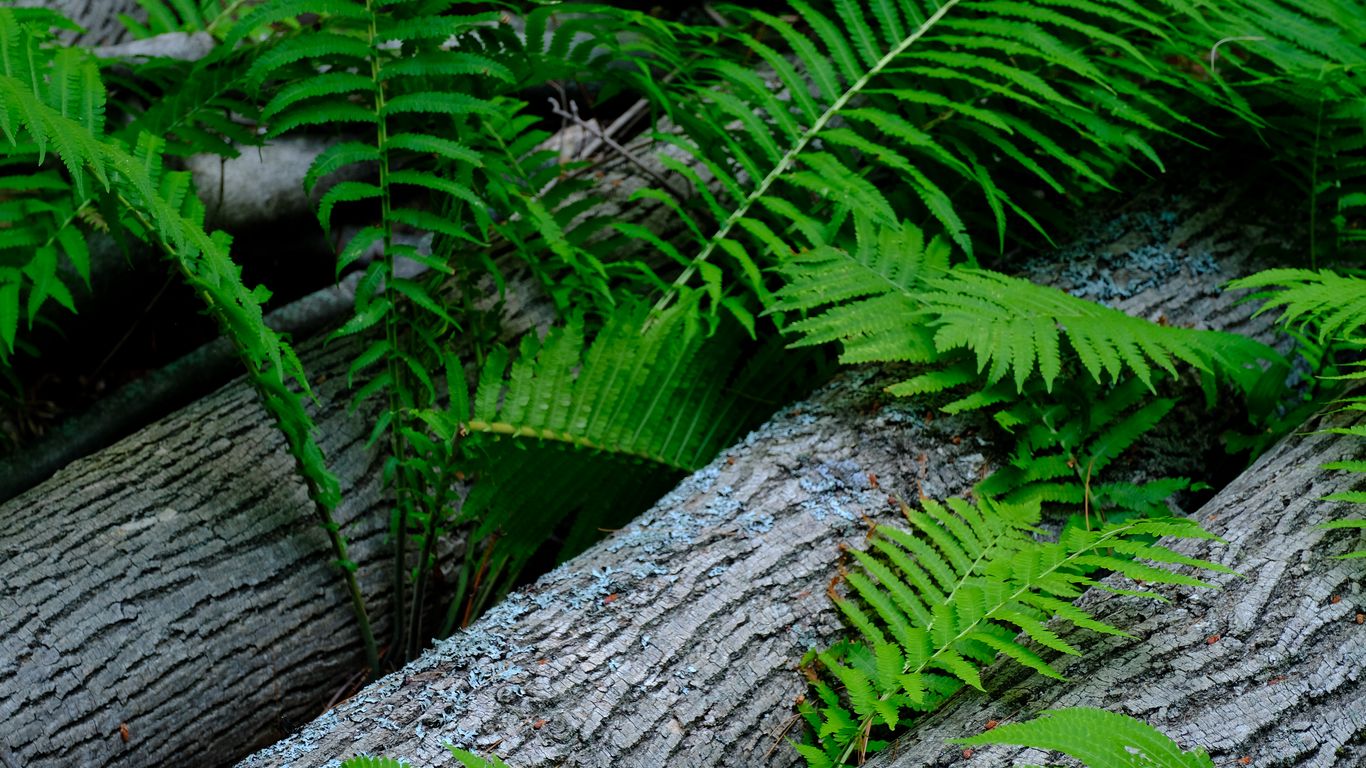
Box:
left=625, top=0, right=1251, bottom=319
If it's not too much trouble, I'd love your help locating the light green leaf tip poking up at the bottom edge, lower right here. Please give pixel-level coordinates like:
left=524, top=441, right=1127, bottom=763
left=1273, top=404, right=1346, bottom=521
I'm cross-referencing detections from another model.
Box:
left=952, top=707, right=1214, bottom=768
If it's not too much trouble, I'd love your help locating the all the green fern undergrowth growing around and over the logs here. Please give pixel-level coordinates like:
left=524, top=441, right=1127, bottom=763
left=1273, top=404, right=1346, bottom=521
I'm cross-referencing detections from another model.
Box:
left=8, top=0, right=1366, bottom=765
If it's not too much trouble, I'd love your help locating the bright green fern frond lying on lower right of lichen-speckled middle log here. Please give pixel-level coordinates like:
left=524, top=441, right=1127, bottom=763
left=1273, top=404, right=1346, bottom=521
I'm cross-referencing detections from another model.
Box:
left=798, top=499, right=1229, bottom=767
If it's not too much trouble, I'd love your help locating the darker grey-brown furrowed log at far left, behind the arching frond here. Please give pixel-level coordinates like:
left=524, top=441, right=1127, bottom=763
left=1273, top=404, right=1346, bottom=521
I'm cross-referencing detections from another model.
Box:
left=0, top=128, right=672, bottom=768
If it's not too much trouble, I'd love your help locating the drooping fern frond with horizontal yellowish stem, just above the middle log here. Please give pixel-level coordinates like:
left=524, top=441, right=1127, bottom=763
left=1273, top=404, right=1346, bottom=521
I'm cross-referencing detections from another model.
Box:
left=419, top=299, right=809, bottom=633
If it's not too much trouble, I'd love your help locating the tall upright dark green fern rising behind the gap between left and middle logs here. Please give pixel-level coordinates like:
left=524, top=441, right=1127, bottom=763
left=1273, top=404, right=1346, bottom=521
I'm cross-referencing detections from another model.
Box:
left=239, top=0, right=672, bottom=657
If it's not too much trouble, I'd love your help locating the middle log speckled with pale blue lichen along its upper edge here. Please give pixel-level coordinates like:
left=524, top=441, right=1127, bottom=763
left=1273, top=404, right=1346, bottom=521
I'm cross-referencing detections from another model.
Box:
left=245, top=185, right=1288, bottom=768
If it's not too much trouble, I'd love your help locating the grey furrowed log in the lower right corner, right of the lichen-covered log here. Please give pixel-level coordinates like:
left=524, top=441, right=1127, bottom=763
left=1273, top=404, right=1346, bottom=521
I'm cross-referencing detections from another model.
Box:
left=867, top=401, right=1366, bottom=768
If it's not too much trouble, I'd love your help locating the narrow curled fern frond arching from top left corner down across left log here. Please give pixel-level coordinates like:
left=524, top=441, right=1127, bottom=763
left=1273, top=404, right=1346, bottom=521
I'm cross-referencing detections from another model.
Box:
left=0, top=1, right=373, bottom=657
